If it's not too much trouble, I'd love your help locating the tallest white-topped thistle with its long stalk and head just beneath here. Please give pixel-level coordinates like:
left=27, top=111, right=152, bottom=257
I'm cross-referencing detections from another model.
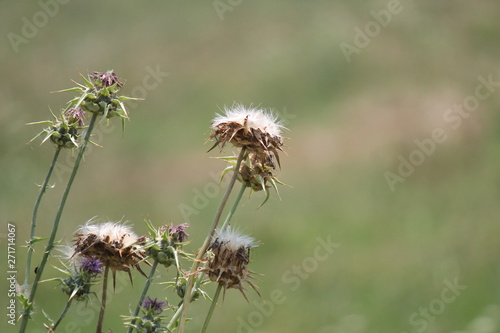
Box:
left=178, top=104, right=284, bottom=333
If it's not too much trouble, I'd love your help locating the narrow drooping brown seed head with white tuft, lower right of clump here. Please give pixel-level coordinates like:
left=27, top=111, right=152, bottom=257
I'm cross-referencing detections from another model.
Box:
left=205, top=228, right=258, bottom=300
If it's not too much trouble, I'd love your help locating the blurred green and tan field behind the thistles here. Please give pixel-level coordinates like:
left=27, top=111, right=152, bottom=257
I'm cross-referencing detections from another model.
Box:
left=0, top=0, right=500, bottom=333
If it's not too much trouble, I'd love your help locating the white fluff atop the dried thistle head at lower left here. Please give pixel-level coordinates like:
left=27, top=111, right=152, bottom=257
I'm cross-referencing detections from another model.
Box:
left=77, top=220, right=138, bottom=247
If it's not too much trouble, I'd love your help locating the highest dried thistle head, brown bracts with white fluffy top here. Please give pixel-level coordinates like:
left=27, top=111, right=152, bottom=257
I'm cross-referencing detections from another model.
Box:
left=210, top=104, right=284, bottom=155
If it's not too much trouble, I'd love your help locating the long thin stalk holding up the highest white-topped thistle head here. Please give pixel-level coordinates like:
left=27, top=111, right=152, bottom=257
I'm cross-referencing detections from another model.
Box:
left=177, top=147, right=246, bottom=333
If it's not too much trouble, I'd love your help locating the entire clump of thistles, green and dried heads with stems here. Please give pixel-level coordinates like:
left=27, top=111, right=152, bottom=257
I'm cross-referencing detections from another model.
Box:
left=19, top=81, right=290, bottom=333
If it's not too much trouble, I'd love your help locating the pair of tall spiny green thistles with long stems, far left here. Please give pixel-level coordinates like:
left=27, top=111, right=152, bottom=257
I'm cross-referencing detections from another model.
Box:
left=18, top=71, right=137, bottom=332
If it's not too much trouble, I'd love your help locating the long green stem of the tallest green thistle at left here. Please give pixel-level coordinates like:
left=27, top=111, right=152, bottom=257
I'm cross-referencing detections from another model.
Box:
left=19, top=113, right=98, bottom=333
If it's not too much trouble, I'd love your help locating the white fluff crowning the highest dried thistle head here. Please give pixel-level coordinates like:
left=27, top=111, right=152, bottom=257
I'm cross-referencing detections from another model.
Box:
left=212, top=104, right=286, bottom=136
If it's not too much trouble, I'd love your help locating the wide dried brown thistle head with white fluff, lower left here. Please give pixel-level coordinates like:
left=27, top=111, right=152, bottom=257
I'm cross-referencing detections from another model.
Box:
left=73, top=221, right=146, bottom=281
